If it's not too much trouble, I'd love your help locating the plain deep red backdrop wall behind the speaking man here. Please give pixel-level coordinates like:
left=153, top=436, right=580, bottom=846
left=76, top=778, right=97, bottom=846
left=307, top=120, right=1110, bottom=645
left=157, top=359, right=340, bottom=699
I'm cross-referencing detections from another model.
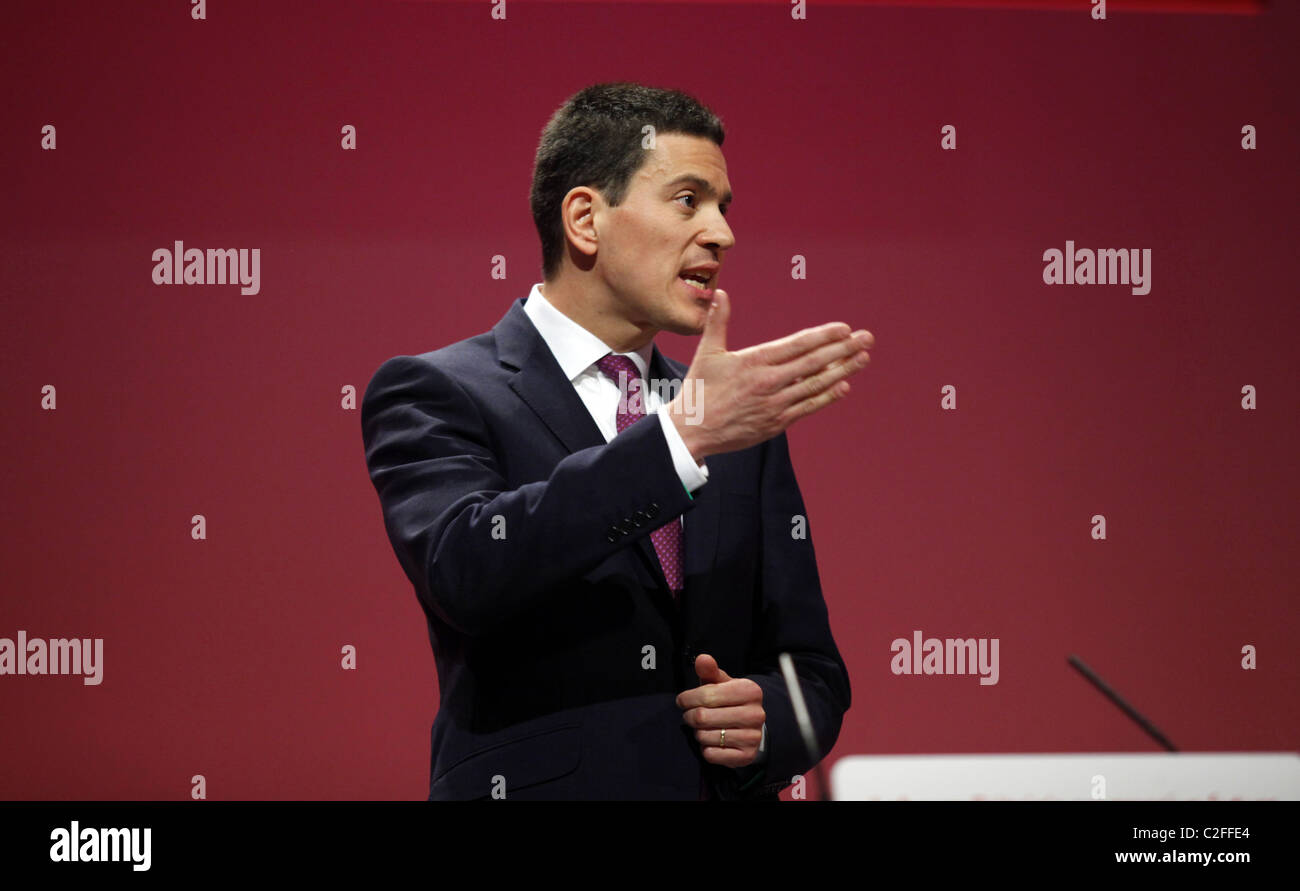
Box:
left=0, top=0, right=1300, bottom=799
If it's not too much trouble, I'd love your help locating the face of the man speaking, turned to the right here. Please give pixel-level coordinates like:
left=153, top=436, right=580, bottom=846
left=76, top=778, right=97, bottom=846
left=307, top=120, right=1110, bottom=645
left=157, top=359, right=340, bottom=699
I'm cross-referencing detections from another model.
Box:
left=594, top=133, right=736, bottom=336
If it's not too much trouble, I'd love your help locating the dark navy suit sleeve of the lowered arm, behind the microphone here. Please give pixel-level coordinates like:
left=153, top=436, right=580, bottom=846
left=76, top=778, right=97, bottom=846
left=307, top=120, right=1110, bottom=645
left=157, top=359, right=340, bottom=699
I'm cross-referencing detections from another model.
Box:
left=733, top=433, right=850, bottom=797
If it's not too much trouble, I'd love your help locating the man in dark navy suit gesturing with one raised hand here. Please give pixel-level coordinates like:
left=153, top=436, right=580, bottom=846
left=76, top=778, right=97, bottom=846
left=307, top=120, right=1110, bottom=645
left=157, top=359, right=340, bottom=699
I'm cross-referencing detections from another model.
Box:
left=361, top=83, right=872, bottom=800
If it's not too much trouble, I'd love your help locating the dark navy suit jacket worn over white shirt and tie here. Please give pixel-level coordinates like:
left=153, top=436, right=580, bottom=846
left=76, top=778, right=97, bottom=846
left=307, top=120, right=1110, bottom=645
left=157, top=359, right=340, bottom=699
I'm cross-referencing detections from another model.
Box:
left=361, top=293, right=849, bottom=800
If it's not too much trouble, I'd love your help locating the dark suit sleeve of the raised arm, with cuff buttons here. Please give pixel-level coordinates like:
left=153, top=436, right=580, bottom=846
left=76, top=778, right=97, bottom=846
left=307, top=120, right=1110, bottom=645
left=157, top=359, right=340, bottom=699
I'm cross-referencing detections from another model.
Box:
left=361, top=356, right=693, bottom=635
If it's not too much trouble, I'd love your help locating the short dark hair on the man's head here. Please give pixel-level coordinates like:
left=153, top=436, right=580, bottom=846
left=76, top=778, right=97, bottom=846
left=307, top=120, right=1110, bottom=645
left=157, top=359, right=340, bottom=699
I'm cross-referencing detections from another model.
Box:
left=529, top=82, right=727, bottom=281
